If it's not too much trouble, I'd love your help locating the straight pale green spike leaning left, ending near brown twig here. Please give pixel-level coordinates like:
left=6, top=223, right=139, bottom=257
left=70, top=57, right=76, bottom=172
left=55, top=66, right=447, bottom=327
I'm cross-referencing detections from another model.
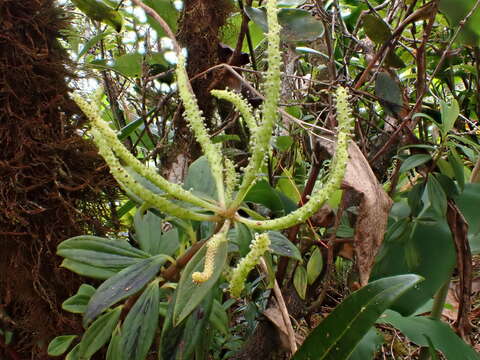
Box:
left=176, top=54, right=225, bottom=203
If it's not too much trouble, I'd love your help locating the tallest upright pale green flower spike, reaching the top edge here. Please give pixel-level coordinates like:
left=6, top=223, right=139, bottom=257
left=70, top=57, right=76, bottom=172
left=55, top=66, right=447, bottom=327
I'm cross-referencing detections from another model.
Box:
left=229, top=0, right=281, bottom=206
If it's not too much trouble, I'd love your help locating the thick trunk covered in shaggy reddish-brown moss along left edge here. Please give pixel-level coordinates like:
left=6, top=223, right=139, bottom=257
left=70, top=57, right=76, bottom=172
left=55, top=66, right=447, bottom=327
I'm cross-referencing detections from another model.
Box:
left=0, top=0, right=116, bottom=359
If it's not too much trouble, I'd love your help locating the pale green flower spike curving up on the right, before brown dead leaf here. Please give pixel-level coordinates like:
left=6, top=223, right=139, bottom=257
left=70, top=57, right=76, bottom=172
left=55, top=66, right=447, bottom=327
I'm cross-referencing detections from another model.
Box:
left=237, top=87, right=353, bottom=230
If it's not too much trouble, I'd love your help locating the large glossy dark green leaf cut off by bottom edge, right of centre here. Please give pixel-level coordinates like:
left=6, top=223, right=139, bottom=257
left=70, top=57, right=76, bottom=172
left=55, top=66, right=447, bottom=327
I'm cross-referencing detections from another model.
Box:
left=293, top=274, right=421, bottom=360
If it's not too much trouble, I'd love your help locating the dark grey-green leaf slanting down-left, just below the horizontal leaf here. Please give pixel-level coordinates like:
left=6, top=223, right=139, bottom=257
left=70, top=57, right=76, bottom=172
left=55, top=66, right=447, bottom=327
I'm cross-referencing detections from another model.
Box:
left=83, top=255, right=166, bottom=325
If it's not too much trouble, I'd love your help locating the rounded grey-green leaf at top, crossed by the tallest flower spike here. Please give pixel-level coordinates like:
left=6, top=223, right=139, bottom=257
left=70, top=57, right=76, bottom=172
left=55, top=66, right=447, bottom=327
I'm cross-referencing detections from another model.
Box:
left=244, top=6, right=325, bottom=42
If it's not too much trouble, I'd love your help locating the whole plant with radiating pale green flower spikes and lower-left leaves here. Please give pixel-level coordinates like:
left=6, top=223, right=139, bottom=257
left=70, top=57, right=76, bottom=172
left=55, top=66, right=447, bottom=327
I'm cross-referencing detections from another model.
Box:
left=51, top=0, right=353, bottom=359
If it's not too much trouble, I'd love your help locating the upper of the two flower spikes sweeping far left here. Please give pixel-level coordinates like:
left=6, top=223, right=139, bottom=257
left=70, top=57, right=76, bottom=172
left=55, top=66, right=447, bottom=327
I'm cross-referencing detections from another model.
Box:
left=72, top=91, right=215, bottom=210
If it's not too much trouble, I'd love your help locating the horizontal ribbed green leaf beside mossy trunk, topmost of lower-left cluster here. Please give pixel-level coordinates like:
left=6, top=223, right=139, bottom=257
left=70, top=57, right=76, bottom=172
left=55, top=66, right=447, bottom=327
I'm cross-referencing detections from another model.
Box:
left=57, top=235, right=149, bottom=271
